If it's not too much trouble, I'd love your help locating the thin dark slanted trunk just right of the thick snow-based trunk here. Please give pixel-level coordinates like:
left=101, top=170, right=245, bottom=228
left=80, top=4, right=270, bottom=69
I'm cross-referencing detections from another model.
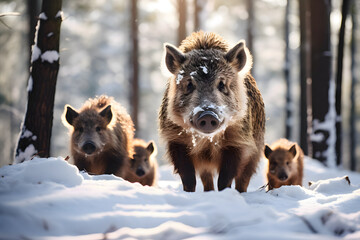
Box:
left=335, top=0, right=350, bottom=165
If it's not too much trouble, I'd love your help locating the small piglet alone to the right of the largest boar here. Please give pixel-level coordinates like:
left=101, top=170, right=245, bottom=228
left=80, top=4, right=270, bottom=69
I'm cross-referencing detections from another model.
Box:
left=264, top=138, right=304, bottom=190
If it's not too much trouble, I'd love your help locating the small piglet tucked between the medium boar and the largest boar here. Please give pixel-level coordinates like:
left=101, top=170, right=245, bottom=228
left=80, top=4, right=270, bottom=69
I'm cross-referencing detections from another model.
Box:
left=125, top=139, right=158, bottom=186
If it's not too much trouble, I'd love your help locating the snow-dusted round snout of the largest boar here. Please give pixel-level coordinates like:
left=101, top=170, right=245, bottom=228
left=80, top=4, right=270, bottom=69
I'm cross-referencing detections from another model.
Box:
left=193, top=110, right=220, bottom=133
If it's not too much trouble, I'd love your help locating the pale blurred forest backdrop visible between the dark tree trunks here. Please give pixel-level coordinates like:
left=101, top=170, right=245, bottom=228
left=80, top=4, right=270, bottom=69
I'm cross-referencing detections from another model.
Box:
left=0, top=0, right=360, bottom=170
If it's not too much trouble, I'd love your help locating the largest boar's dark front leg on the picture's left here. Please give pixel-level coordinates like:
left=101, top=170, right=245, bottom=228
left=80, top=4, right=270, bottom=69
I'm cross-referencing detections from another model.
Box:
left=168, top=142, right=196, bottom=192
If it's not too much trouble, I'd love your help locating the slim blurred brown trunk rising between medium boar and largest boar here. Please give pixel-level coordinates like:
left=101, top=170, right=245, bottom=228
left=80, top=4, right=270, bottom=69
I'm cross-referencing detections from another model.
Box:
left=129, top=0, right=139, bottom=133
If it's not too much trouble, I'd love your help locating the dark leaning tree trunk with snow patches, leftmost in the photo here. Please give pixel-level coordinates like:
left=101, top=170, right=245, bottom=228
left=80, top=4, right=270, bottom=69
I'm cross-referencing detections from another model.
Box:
left=14, top=0, right=62, bottom=163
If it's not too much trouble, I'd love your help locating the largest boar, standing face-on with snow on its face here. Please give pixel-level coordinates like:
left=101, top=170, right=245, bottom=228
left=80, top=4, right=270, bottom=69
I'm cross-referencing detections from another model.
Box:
left=159, top=32, right=265, bottom=192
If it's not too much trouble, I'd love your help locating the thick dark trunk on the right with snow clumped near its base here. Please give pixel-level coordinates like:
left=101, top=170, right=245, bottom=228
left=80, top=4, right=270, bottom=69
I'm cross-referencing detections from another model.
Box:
left=310, top=0, right=336, bottom=167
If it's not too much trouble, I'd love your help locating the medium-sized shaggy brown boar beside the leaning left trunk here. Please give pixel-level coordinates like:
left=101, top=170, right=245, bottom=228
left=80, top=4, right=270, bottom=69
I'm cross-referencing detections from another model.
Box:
left=62, top=95, right=134, bottom=177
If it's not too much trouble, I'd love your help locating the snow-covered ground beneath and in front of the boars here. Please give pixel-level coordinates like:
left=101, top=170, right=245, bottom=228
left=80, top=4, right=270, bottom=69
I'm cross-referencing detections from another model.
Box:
left=0, top=158, right=360, bottom=240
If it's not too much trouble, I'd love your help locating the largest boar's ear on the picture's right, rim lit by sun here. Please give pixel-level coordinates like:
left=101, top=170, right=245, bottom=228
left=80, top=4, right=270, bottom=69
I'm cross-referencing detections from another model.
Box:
left=225, top=41, right=252, bottom=73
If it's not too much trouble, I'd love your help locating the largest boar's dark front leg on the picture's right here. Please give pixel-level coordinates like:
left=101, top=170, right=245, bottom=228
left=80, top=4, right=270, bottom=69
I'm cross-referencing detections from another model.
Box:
left=218, top=147, right=240, bottom=191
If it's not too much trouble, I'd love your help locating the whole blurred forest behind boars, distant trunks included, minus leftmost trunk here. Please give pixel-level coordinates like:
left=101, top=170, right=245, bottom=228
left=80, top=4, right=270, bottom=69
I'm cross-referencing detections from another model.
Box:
left=0, top=0, right=360, bottom=170
